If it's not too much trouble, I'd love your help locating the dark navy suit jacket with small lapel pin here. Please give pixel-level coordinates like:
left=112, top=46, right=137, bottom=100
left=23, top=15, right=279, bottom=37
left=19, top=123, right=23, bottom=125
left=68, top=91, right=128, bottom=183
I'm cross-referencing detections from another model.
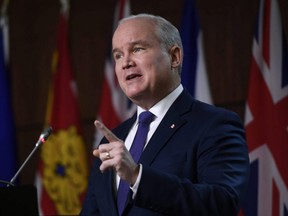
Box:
left=81, top=90, right=249, bottom=216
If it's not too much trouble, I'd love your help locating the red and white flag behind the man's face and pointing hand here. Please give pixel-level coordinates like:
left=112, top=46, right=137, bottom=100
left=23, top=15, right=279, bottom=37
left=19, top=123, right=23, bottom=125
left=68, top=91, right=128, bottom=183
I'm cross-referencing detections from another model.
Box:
left=94, top=0, right=136, bottom=147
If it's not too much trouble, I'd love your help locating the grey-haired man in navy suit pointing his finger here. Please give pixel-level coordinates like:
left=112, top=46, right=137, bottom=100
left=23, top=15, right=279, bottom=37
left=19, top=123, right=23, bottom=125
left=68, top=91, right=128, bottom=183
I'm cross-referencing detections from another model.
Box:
left=81, top=14, right=249, bottom=216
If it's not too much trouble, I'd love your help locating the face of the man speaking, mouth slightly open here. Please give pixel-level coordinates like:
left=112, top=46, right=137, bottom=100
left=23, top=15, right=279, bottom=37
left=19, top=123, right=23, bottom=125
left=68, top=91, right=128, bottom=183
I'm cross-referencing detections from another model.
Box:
left=112, top=19, right=180, bottom=109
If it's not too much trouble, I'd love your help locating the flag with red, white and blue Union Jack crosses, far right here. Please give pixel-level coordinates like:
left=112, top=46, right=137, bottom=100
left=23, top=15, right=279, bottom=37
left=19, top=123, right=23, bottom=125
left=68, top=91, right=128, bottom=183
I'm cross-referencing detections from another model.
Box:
left=242, top=0, right=288, bottom=216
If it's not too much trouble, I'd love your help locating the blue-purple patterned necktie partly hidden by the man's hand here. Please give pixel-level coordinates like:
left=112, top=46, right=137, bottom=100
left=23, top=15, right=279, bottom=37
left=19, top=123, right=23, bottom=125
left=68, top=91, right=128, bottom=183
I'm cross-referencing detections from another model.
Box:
left=117, top=111, right=154, bottom=215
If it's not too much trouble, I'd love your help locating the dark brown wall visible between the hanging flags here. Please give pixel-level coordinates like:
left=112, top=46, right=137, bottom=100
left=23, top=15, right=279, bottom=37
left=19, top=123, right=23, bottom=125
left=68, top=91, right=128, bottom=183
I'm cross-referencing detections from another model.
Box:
left=4, top=0, right=288, bottom=184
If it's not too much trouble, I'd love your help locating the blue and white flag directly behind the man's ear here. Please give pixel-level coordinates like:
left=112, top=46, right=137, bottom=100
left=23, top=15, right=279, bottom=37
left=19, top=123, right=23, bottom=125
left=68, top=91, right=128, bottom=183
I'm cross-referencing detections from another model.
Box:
left=180, top=0, right=212, bottom=103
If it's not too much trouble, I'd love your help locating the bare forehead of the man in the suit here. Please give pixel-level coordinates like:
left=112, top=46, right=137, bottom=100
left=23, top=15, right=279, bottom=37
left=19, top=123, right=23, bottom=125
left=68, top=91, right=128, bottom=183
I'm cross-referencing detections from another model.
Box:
left=112, top=18, right=158, bottom=47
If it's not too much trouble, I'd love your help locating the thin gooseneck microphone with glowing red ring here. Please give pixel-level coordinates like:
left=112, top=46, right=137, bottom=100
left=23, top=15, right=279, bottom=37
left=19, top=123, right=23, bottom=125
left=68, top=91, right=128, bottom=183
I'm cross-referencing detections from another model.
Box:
left=7, top=127, right=52, bottom=187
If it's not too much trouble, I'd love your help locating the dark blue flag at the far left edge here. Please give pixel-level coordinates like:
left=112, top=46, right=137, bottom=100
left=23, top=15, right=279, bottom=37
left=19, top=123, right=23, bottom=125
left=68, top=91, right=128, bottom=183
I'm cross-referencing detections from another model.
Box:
left=0, top=1, right=17, bottom=186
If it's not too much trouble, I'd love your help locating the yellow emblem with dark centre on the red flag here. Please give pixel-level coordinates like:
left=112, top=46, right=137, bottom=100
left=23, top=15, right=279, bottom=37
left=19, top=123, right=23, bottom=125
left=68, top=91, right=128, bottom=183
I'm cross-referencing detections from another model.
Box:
left=41, top=126, right=88, bottom=215
